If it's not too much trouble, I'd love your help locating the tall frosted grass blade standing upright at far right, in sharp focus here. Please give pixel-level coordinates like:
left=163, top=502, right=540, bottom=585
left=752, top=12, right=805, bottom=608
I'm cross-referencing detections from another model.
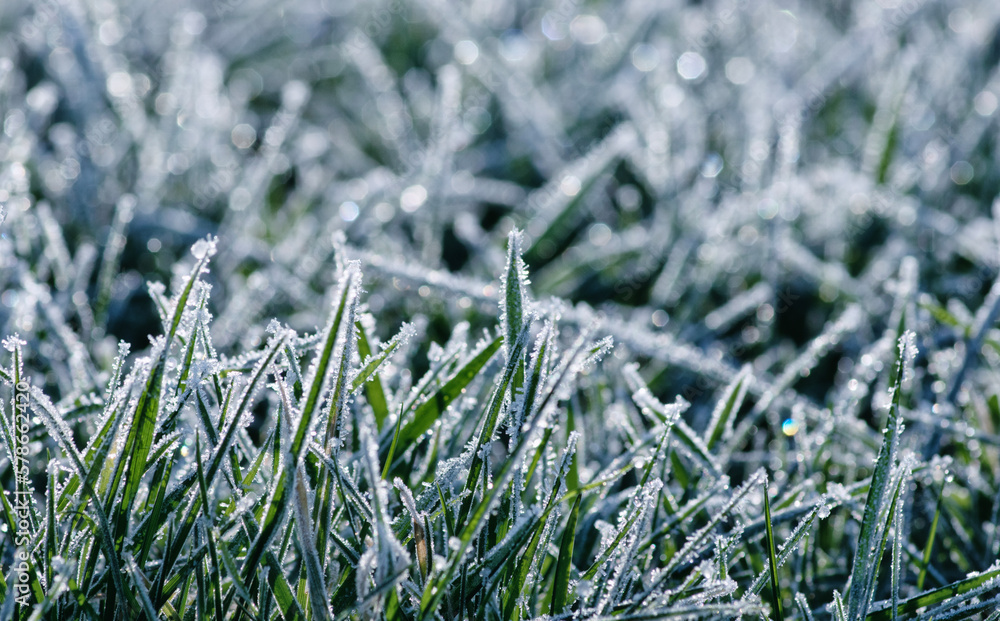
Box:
left=847, top=332, right=916, bottom=619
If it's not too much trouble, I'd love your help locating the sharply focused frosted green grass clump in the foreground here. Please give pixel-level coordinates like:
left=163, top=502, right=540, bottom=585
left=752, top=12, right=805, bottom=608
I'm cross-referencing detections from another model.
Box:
left=0, top=231, right=1000, bottom=619
